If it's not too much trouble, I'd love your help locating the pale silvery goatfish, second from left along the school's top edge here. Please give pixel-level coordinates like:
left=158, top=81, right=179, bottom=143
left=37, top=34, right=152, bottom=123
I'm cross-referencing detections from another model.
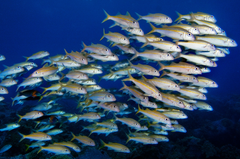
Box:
left=136, top=13, right=172, bottom=25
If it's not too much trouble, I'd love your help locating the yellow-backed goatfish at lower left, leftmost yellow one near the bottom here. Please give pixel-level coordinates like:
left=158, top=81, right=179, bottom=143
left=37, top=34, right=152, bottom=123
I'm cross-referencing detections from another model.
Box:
left=19, top=132, right=52, bottom=142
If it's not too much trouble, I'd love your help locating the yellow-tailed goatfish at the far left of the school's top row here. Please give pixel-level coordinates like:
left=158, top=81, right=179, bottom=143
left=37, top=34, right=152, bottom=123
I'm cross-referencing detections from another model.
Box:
left=102, top=10, right=139, bottom=28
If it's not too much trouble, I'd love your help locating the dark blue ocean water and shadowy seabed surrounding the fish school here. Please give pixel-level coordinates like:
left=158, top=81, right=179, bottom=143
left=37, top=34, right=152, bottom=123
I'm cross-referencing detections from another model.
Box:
left=0, top=0, right=240, bottom=158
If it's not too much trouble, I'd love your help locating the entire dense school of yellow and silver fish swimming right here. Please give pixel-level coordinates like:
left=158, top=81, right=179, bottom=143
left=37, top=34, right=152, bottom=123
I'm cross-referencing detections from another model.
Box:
left=0, top=11, right=237, bottom=157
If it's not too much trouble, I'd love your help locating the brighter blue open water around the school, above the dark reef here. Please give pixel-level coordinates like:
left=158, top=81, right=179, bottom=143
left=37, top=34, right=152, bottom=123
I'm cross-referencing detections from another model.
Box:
left=0, top=0, right=240, bottom=158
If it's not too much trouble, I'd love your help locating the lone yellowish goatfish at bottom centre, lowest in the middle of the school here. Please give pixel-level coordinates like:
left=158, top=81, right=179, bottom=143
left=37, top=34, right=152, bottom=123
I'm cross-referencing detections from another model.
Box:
left=99, top=140, right=130, bottom=153
